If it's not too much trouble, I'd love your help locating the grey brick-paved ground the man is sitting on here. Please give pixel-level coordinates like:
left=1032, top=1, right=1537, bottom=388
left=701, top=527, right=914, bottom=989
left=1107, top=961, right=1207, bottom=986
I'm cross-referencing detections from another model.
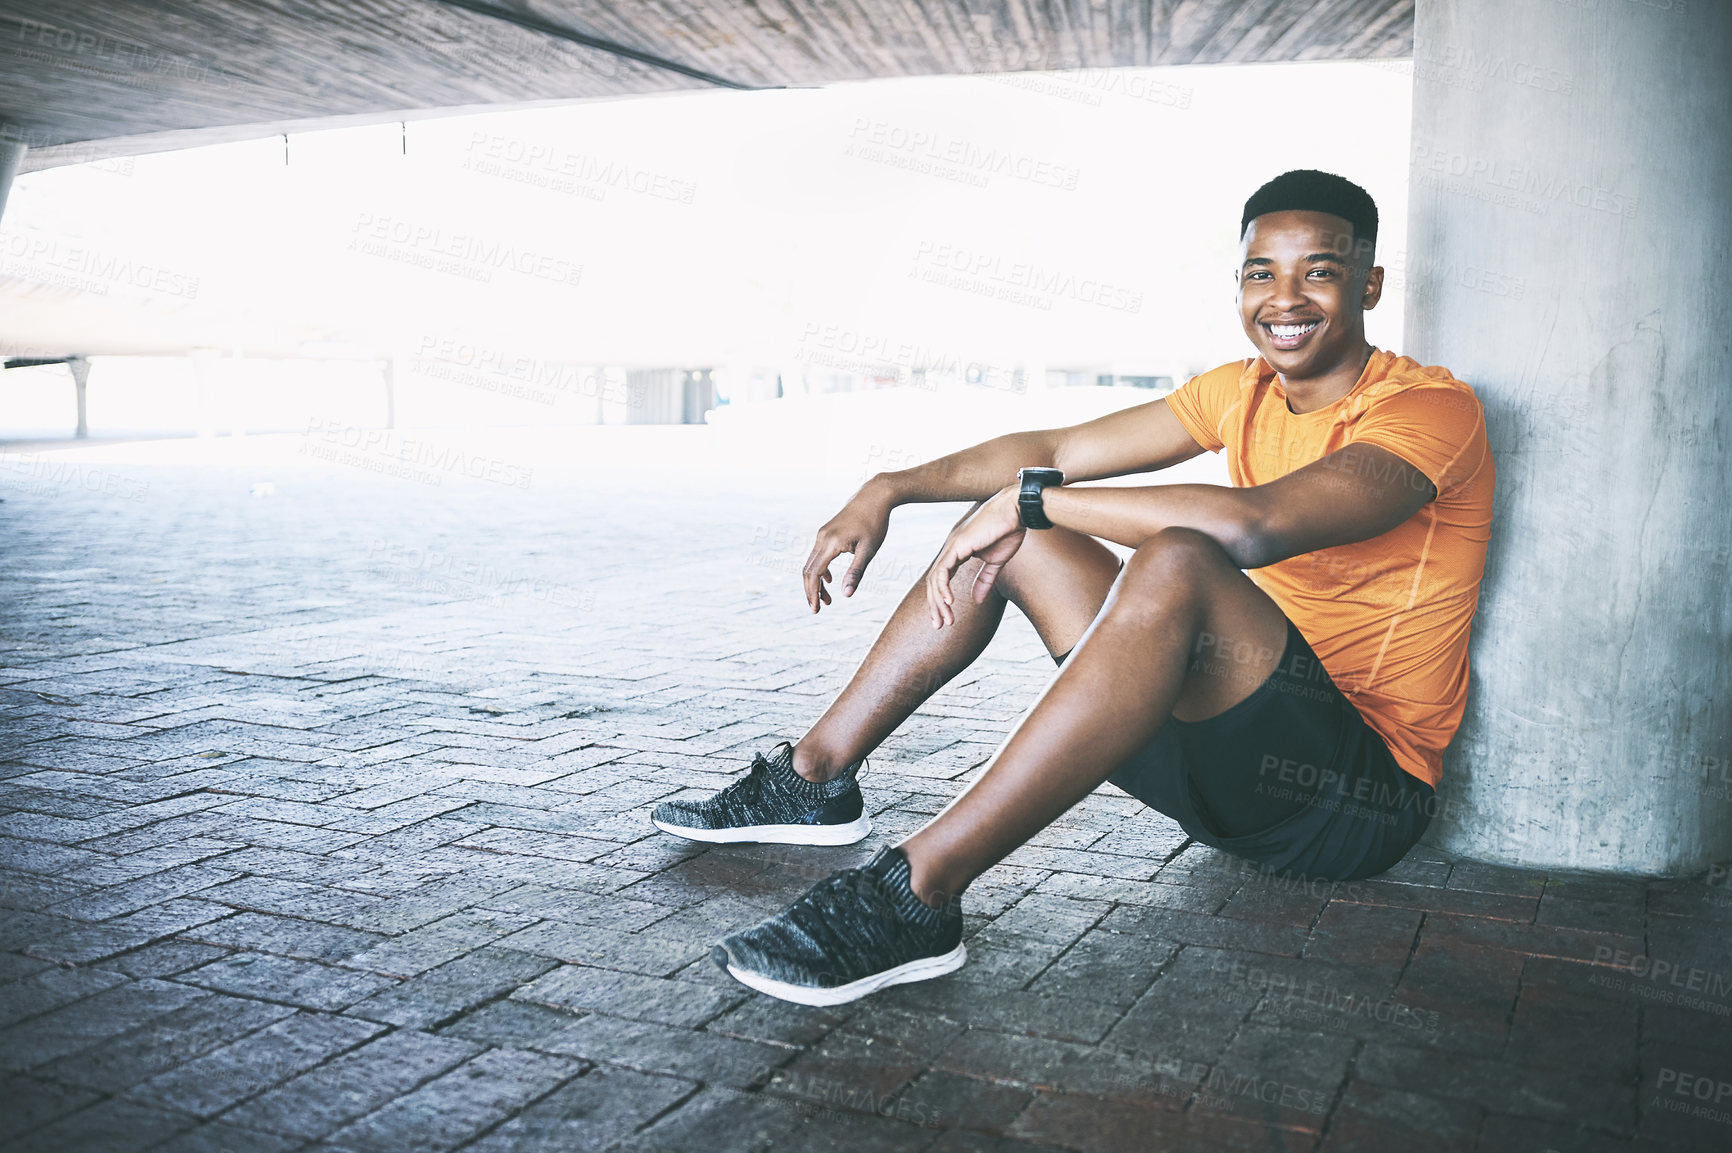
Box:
left=0, top=429, right=1732, bottom=1153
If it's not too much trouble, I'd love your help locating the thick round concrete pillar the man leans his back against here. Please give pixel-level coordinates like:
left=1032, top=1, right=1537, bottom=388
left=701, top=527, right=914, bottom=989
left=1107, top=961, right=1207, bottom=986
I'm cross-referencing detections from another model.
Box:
left=1406, top=0, right=1732, bottom=874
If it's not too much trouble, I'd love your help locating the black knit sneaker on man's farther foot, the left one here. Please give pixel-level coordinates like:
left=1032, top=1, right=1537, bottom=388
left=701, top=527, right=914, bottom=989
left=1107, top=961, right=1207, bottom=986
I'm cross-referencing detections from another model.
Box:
left=650, top=741, right=871, bottom=845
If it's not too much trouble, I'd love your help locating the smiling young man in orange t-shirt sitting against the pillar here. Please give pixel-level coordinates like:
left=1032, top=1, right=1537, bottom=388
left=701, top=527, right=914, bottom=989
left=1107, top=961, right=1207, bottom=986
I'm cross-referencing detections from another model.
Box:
left=653, top=170, right=1495, bottom=1004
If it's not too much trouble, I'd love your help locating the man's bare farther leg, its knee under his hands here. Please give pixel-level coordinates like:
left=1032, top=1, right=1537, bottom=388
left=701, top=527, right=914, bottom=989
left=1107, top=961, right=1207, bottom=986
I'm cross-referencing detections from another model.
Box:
left=793, top=528, right=1119, bottom=781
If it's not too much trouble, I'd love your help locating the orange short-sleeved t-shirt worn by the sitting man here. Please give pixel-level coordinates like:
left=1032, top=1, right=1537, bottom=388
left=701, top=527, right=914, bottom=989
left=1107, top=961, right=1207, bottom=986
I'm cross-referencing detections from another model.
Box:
left=1167, top=348, right=1496, bottom=786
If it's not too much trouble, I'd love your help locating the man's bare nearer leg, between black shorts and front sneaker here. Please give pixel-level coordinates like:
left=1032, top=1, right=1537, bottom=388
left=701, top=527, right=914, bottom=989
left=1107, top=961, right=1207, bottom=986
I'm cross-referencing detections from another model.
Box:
left=901, top=528, right=1287, bottom=904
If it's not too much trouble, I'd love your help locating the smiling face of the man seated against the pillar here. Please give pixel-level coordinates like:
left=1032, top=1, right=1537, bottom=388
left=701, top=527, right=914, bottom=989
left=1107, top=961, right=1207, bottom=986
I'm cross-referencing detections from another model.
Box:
left=1238, top=211, right=1384, bottom=381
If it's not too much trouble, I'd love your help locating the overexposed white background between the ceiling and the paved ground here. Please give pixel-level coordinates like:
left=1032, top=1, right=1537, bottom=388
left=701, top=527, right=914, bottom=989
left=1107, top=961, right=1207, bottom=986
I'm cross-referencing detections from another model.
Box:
left=0, top=64, right=1410, bottom=440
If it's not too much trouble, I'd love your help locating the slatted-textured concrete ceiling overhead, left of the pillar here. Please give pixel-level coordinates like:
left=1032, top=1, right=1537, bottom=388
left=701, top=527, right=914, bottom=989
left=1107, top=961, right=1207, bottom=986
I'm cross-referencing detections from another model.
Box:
left=0, top=0, right=1413, bottom=171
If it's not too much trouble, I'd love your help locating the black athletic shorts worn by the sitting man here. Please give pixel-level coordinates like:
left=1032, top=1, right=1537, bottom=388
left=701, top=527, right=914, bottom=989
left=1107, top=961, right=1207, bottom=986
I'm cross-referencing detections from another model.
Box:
left=1080, top=622, right=1438, bottom=881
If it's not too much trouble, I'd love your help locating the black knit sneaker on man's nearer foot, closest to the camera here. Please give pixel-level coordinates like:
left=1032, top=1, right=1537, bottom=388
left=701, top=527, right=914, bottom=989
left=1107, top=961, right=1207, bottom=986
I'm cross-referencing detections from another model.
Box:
left=710, top=848, right=968, bottom=1004
